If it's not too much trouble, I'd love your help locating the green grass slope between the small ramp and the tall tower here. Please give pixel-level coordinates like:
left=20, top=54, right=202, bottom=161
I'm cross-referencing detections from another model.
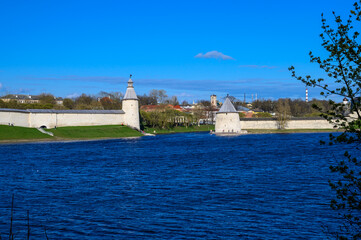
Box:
left=47, top=125, right=142, bottom=139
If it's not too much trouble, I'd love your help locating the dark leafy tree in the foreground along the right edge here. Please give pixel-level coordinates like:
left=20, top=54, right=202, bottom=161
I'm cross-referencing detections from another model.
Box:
left=289, top=0, right=361, bottom=239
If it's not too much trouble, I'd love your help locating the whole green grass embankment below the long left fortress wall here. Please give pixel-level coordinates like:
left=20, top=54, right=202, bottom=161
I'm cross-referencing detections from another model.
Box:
left=0, top=125, right=142, bottom=141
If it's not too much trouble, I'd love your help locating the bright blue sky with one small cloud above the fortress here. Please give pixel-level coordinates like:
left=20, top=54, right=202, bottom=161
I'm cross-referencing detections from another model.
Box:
left=0, top=0, right=353, bottom=101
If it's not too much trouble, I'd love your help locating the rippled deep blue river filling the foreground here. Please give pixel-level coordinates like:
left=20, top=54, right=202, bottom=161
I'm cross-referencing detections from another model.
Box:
left=0, top=133, right=345, bottom=239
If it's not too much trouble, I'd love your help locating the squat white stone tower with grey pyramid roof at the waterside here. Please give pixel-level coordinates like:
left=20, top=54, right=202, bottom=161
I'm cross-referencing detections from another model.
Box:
left=215, top=95, right=242, bottom=134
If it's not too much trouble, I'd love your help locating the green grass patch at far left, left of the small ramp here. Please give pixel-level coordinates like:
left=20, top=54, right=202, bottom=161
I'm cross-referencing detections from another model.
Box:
left=0, top=125, right=52, bottom=140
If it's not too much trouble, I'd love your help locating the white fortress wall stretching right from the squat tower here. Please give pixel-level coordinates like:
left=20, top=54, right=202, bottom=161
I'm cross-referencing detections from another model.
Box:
left=240, top=118, right=333, bottom=129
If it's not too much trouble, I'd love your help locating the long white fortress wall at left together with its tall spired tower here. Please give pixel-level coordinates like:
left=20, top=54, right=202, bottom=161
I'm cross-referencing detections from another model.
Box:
left=0, top=78, right=140, bottom=130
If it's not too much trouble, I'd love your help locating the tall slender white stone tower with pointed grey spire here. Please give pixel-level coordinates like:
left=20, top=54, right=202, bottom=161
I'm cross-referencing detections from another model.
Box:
left=122, top=75, right=140, bottom=130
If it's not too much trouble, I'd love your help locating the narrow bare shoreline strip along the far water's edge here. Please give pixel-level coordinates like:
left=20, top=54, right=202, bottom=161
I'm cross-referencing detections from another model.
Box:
left=0, top=129, right=343, bottom=145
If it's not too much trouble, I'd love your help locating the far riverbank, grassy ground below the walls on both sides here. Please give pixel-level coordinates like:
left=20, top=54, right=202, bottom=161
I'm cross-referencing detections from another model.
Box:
left=0, top=125, right=342, bottom=144
